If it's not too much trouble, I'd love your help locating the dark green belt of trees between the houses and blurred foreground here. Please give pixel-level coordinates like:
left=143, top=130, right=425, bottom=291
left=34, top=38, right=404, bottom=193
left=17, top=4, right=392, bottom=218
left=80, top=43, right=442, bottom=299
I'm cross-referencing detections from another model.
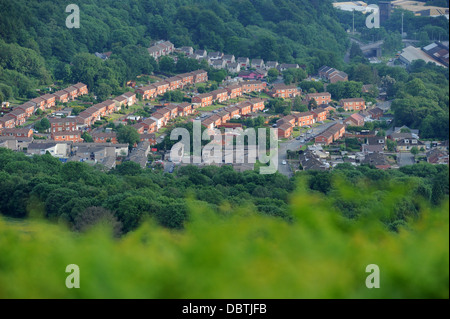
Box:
left=0, top=149, right=449, bottom=235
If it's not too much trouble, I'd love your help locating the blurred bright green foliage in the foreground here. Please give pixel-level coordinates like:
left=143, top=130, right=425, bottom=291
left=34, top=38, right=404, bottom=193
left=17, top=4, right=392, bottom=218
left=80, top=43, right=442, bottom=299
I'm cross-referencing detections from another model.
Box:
left=0, top=183, right=449, bottom=299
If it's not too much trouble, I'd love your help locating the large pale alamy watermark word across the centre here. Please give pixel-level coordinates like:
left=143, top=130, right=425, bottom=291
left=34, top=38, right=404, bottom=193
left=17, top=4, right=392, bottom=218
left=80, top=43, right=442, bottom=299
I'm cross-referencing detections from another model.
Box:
left=170, top=120, right=278, bottom=174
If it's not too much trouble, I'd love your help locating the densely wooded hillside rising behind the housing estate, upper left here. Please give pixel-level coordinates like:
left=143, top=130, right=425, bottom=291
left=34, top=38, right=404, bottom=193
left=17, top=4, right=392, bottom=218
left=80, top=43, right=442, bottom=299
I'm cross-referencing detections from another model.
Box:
left=0, top=0, right=347, bottom=97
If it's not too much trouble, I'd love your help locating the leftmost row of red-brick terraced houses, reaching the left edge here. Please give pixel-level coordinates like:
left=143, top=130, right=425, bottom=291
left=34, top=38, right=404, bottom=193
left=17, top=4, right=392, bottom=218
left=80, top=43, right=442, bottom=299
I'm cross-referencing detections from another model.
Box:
left=0, top=82, right=88, bottom=130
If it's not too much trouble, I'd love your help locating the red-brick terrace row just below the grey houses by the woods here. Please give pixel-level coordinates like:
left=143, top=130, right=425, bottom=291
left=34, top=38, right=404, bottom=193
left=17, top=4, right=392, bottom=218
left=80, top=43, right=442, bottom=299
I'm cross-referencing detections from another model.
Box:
left=136, top=70, right=208, bottom=100
